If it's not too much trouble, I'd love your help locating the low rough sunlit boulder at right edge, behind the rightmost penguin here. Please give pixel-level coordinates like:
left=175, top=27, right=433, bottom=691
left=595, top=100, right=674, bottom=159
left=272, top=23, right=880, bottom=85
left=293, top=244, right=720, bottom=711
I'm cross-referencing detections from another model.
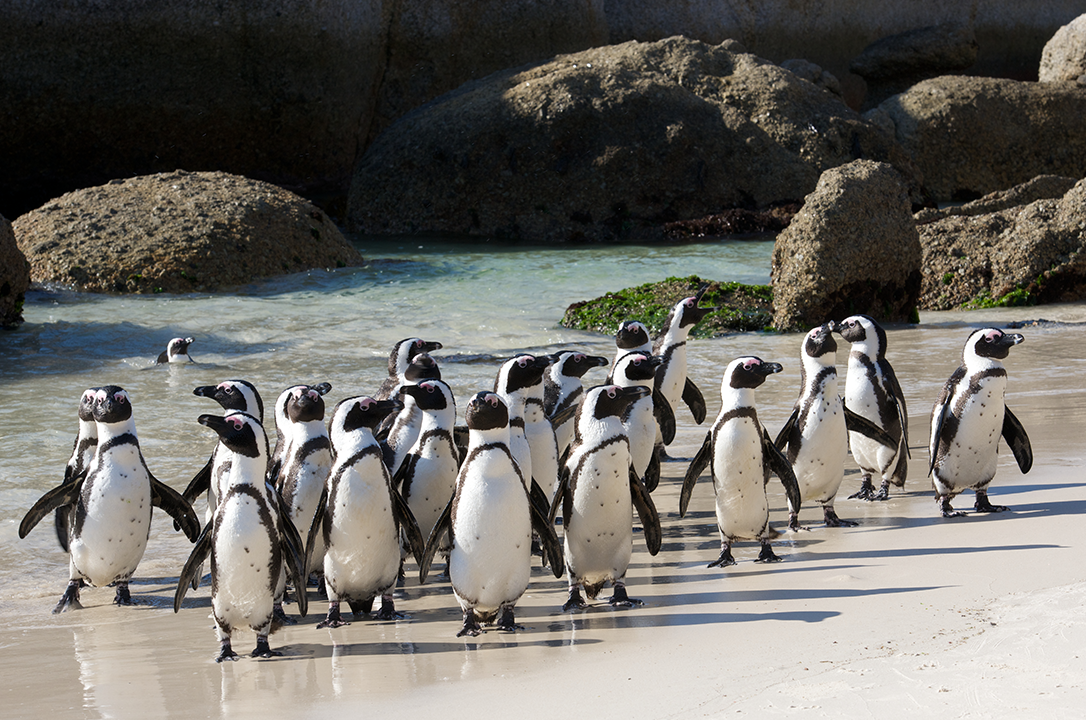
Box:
left=919, top=180, right=1086, bottom=310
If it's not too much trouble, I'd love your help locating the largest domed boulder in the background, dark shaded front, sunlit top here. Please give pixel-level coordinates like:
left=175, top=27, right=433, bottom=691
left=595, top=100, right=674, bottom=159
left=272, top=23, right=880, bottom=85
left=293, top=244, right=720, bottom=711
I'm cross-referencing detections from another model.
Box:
left=348, top=38, right=911, bottom=242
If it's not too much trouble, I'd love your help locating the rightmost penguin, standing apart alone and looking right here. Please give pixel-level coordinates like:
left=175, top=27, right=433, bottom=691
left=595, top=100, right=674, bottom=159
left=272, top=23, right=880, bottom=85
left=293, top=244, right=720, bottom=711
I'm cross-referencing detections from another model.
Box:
left=927, top=328, right=1033, bottom=517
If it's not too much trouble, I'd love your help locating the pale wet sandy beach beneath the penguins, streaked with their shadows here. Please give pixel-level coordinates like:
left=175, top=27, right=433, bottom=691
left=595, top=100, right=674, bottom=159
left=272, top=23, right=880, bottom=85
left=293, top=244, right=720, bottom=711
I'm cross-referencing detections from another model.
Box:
left=0, top=306, right=1086, bottom=720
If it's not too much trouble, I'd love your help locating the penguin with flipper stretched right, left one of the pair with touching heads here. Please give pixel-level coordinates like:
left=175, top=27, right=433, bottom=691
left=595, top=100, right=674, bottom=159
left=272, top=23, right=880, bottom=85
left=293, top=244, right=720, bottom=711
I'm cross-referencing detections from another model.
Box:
left=773, top=321, right=897, bottom=530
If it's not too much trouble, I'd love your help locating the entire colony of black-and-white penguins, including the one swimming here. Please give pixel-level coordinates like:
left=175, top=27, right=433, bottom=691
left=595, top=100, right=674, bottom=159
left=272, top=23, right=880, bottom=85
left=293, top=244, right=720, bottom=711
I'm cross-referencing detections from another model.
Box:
left=20, top=308, right=1033, bottom=661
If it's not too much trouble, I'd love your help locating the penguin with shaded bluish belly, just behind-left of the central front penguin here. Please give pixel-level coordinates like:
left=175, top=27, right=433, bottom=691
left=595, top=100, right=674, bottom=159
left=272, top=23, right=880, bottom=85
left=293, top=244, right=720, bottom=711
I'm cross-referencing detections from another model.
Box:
left=392, top=380, right=460, bottom=573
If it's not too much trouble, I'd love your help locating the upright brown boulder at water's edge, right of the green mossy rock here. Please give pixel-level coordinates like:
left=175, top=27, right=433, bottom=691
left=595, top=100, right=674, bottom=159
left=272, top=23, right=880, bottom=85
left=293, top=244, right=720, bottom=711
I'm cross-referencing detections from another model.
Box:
left=771, top=161, right=920, bottom=331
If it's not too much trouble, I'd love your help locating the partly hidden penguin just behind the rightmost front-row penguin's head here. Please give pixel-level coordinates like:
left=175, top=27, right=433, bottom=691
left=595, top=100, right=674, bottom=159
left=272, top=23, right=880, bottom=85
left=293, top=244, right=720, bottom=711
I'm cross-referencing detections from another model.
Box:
left=608, top=351, right=661, bottom=492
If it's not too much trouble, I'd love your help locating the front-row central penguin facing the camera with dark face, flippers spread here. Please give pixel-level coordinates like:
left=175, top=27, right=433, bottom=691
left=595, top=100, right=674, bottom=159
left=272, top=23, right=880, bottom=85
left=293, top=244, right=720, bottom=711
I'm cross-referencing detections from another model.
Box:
left=419, top=392, right=564, bottom=637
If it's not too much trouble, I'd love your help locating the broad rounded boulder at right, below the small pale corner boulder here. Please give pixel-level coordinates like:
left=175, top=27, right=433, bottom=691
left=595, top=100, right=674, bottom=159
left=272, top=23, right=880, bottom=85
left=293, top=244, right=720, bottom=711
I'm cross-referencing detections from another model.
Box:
left=871, top=76, right=1086, bottom=202
